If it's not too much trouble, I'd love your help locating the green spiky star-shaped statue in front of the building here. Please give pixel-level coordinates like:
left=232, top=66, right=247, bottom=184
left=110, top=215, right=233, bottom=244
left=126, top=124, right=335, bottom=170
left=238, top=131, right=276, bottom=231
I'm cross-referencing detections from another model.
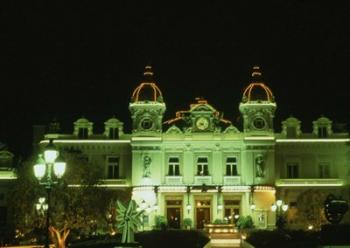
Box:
left=117, top=200, right=144, bottom=243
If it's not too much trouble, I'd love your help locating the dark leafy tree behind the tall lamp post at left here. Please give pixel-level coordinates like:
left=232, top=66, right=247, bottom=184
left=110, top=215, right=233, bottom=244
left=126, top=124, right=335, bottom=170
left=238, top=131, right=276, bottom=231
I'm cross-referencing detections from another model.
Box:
left=10, top=149, right=129, bottom=246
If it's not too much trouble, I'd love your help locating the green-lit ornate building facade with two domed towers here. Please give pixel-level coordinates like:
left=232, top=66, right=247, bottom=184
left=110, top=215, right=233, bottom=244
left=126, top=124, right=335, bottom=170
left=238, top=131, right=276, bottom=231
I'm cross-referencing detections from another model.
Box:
left=41, top=66, right=350, bottom=231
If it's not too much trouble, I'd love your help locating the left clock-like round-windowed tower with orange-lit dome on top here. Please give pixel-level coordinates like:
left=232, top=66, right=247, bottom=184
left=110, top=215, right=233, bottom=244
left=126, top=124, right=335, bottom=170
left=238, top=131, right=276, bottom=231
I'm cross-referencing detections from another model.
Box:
left=129, top=66, right=166, bottom=136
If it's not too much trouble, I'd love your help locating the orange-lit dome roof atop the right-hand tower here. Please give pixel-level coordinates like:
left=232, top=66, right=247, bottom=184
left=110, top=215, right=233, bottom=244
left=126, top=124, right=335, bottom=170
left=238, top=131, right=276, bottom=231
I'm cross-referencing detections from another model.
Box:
left=242, top=66, right=274, bottom=102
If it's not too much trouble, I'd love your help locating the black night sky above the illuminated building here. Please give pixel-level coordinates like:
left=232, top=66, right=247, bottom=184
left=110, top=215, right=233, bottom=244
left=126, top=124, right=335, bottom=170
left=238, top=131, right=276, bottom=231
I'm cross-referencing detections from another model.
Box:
left=0, top=0, right=350, bottom=157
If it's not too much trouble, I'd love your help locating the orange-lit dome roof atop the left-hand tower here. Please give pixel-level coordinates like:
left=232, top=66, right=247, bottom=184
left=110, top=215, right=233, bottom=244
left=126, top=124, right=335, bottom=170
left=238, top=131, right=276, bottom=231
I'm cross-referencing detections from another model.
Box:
left=131, top=66, right=163, bottom=102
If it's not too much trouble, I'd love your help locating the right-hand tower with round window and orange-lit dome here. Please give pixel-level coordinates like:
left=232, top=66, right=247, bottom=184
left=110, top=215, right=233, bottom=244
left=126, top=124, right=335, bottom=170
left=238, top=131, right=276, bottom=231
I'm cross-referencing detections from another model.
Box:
left=239, top=66, right=277, bottom=135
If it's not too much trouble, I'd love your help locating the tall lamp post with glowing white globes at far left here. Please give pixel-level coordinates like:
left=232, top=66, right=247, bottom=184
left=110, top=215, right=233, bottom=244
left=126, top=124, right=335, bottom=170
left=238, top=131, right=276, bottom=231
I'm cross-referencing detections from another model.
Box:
left=34, top=139, right=66, bottom=248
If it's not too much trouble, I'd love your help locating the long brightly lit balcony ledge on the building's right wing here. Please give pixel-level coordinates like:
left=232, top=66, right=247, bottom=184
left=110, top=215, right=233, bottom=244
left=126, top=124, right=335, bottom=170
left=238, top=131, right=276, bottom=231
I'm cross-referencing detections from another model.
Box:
left=276, top=178, right=345, bottom=187
